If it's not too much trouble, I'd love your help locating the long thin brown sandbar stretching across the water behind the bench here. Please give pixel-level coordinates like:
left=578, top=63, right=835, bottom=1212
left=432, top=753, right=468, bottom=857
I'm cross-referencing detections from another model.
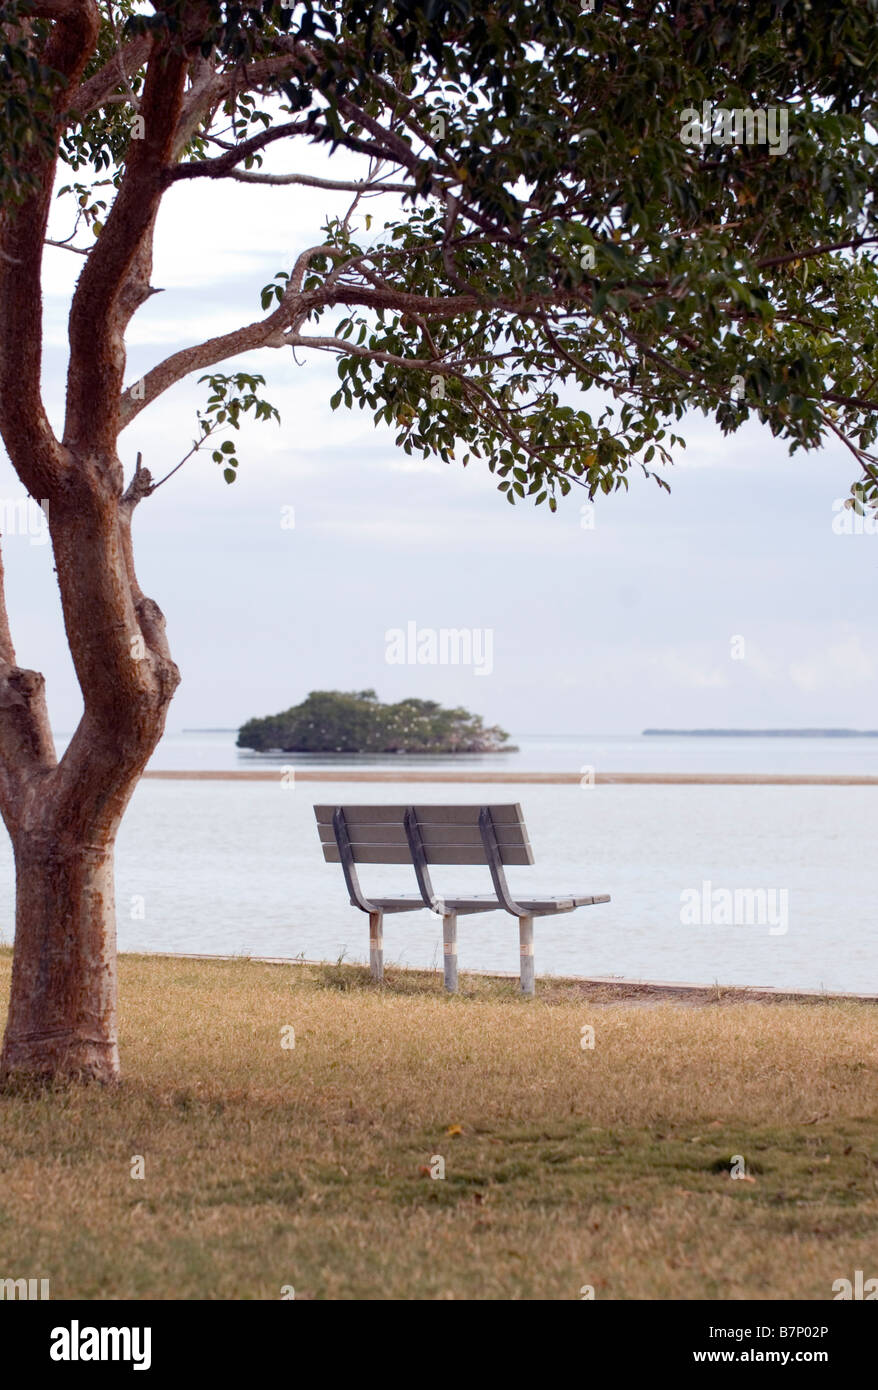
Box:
left=143, top=765, right=878, bottom=787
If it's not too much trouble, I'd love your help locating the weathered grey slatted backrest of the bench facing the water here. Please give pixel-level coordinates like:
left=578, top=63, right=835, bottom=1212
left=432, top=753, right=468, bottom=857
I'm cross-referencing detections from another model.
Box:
left=314, top=802, right=533, bottom=865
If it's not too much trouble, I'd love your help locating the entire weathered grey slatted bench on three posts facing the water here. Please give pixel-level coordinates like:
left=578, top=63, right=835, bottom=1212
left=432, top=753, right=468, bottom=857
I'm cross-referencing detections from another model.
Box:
left=314, top=803, right=610, bottom=995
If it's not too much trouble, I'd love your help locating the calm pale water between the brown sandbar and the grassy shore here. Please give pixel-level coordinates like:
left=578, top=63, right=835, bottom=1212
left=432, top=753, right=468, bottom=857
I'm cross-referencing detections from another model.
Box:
left=0, top=778, right=878, bottom=992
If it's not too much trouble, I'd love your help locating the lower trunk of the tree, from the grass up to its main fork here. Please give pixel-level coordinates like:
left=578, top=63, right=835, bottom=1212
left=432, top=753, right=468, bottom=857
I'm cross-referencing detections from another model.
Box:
left=0, top=470, right=179, bottom=1081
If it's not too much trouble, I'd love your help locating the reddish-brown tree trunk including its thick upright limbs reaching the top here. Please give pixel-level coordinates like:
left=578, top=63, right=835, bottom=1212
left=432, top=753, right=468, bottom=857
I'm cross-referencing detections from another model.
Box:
left=0, top=0, right=184, bottom=1080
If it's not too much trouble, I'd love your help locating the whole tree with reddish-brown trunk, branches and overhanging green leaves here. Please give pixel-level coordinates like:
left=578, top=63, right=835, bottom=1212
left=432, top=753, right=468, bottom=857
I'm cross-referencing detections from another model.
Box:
left=0, top=0, right=878, bottom=1080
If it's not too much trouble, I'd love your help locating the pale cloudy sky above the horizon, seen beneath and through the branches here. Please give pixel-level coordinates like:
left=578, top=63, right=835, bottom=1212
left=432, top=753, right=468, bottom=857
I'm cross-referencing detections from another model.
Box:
left=0, top=141, right=878, bottom=734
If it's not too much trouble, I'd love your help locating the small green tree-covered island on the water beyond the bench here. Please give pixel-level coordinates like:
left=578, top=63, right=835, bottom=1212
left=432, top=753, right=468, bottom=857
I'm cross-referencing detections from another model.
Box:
left=238, top=691, right=518, bottom=753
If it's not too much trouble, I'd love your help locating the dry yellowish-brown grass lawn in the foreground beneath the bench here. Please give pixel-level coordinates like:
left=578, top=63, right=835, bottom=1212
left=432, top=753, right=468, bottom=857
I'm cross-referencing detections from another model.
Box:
left=0, top=949, right=878, bottom=1300
